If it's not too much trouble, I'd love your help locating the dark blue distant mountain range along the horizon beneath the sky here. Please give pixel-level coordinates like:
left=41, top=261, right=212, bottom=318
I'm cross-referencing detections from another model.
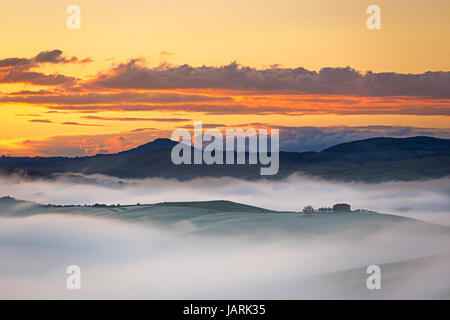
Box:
left=0, top=137, right=450, bottom=182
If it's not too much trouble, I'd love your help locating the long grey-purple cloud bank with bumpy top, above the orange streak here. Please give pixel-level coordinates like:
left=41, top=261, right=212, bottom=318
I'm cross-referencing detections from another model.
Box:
left=91, top=59, right=450, bottom=98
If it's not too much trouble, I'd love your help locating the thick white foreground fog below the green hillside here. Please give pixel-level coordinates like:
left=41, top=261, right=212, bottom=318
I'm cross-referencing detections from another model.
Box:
left=0, top=214, right=450, bottom=299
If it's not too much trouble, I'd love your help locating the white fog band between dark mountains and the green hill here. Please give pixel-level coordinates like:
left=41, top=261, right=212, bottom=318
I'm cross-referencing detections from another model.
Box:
left=0, top=175, right=450, bottom=226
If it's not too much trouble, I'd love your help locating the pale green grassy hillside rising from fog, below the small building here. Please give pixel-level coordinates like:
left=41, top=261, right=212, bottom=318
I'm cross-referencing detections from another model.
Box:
left=0, top=198, right=450, bottom=235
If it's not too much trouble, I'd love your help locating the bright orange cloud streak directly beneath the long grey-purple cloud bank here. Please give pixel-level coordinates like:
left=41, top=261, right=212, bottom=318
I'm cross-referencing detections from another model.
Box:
left=4, top=91, right=450, bottom=115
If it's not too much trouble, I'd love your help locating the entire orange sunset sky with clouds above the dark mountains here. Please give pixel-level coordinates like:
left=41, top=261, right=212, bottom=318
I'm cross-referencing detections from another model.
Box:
left=0, top=0, right=450, bottom=156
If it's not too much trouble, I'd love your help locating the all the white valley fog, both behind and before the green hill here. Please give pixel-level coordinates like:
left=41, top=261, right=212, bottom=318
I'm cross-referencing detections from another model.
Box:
left=0, top=175, right=450, bottom=299
